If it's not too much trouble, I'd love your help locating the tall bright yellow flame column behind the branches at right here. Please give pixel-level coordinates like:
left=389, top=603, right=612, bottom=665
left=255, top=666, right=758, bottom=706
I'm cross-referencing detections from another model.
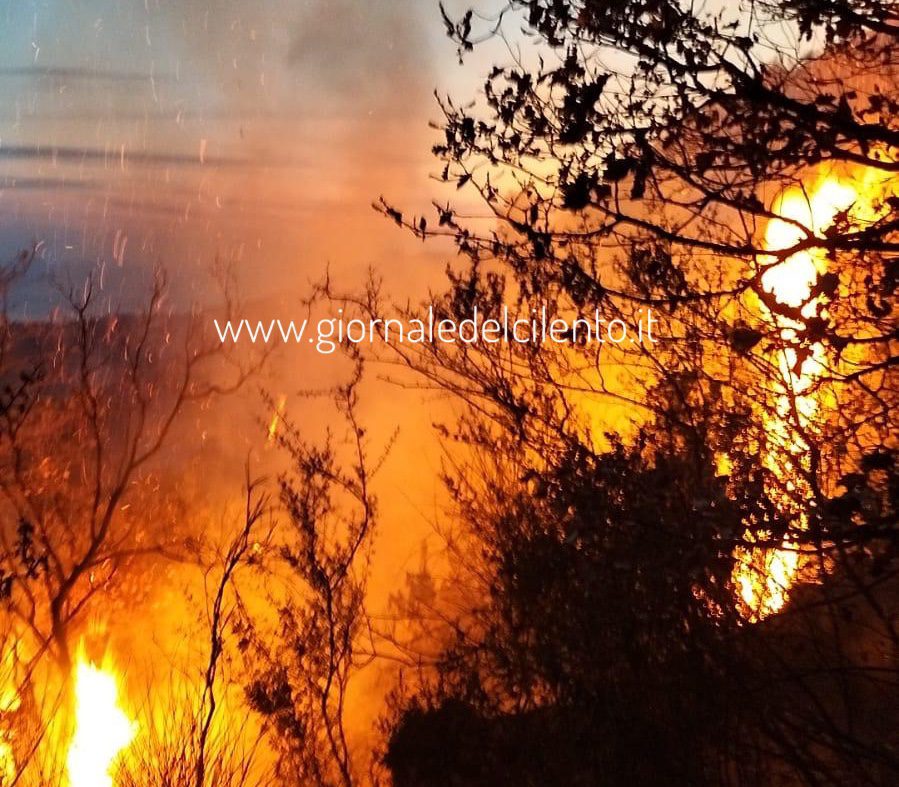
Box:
left=734, top=172, right=884, bottom=620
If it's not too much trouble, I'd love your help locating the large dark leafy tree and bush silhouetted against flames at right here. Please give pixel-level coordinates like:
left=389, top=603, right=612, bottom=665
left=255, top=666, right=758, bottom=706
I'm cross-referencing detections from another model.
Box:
left=382, top=0, right=899, bottom=784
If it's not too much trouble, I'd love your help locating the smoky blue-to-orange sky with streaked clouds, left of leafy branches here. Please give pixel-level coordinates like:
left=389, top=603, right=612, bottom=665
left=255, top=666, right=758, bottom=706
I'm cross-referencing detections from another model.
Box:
left=0, top=0, right=500, bottom=317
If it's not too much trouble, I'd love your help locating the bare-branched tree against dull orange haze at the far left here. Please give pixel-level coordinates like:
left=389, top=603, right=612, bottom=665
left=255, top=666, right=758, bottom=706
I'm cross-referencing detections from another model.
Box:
left=0, top=268, right=260, bottom=674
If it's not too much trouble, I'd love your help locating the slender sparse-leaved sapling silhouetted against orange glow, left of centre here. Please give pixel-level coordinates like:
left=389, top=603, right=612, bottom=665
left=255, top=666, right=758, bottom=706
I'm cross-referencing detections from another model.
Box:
left=244, top=356, right=392, bottom=787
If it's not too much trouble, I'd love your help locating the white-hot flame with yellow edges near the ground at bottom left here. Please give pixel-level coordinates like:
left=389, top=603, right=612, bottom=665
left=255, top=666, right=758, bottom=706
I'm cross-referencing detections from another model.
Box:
left=66, top=653, right=137, bottom=787
